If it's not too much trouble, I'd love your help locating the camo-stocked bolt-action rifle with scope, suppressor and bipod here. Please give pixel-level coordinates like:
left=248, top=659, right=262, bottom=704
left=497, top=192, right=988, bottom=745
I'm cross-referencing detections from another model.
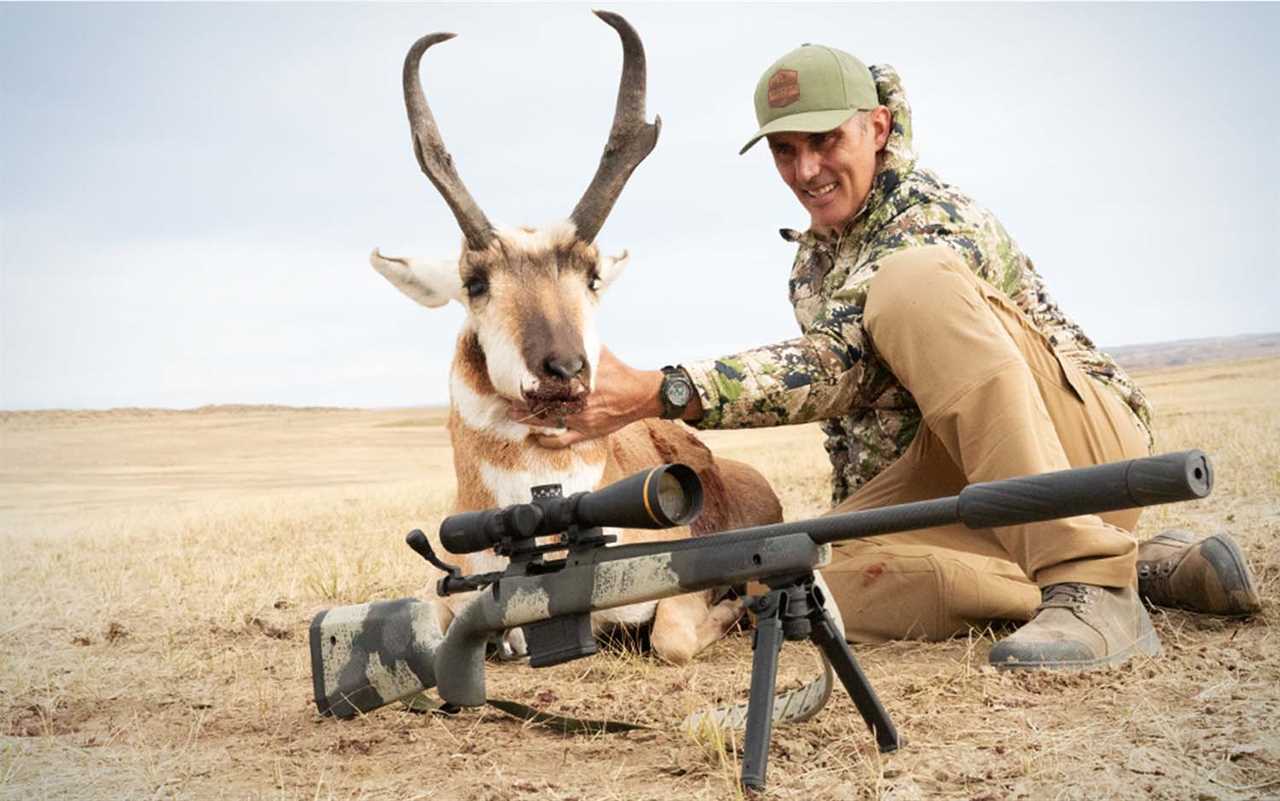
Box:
left=310, top=450, right=1212, bottom=788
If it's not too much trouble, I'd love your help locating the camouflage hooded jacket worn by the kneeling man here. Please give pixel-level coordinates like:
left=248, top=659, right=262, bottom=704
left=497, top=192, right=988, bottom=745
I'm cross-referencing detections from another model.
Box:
left=684, top=65, right=1151, bottom=503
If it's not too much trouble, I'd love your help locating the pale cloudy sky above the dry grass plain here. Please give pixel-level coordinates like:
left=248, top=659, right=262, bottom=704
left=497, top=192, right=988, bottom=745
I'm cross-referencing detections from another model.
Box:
left=0, top=4, right=1280, bottom=409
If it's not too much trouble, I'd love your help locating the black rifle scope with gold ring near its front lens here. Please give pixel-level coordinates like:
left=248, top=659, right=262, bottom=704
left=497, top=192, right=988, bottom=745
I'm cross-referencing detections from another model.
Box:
left=440, top=464, right=703, bottom=554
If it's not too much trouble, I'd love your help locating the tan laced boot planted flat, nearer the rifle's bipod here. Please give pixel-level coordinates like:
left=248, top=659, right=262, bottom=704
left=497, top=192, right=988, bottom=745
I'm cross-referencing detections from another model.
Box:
left=987, top=582, right=1160, bottom=670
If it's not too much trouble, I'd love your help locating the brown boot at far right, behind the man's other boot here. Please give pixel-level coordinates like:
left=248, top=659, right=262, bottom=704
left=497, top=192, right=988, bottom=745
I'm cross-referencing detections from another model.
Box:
left=1138, top=530, right=1262, bottom=617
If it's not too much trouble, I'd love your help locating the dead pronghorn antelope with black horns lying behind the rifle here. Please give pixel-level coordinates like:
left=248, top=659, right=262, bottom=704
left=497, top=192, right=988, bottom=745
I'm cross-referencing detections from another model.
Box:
left=370, top=12, right=781, bottom=663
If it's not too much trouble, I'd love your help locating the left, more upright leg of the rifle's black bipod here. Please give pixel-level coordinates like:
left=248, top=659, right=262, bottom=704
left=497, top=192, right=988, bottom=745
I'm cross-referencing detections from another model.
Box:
left=742, top=590, right=786, bottom=791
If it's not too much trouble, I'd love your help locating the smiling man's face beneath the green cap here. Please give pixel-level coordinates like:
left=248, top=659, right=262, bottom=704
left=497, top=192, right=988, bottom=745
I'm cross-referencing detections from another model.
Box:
left=768, top=106, right=892, bottom=230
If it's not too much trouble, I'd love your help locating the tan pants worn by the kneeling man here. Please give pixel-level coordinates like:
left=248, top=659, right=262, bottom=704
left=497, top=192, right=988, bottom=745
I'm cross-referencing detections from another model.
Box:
left=823, top=247, right=1148, bottom=642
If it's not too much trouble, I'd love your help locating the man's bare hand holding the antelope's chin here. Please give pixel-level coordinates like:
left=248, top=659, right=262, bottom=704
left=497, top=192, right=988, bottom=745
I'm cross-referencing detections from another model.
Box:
left=511, top=347, right=662, bottom=448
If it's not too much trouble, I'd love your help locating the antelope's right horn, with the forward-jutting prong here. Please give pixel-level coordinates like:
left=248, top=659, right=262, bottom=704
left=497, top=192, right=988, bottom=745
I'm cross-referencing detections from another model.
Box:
left=570, top=12, right=662, bottom=242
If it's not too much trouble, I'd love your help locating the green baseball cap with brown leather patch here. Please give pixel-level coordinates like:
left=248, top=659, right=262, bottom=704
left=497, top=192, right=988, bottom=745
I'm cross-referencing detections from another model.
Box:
left=739, top=45, right=879, bottom=155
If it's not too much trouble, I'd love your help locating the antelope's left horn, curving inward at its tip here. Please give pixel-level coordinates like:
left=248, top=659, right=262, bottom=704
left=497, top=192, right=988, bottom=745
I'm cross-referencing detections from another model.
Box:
left=404, top=33, right=493, bottom=251
